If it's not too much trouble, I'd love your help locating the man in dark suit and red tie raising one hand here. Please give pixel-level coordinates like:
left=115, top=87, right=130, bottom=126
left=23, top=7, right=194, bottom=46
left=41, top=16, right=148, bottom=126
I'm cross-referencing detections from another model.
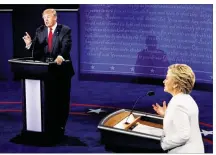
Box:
left=23, top=9, right=74, bottom=140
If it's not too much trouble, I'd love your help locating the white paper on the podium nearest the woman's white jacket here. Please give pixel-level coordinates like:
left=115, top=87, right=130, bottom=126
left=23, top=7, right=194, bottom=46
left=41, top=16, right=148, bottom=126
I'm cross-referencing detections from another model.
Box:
left=132, top=123, right=163, bottom=137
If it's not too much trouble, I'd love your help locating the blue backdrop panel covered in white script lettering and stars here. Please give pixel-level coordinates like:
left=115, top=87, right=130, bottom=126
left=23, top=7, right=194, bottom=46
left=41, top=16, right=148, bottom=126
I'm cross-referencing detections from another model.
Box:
left=80, top=4, right=213, bottom=83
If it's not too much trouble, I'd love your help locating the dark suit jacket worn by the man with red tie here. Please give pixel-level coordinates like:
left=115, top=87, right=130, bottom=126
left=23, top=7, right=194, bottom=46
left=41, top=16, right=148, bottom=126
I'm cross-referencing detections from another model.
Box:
left=30, top=24, right=74, bottom=75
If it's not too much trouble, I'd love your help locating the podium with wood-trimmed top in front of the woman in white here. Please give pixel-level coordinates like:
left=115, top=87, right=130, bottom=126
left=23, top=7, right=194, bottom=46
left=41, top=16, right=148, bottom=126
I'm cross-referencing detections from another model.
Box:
left=98, top=109, right=165, bottom=153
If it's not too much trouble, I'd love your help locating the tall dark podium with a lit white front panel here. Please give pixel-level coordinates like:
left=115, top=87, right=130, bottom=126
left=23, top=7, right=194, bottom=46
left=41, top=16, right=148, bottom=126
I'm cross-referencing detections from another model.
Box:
left=8, top=57, right=71, bottom=144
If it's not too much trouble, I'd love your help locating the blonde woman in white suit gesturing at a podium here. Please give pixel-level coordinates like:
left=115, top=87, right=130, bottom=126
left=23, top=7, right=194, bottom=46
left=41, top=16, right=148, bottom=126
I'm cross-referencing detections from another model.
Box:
left=152, top=64, right=204, bottom=153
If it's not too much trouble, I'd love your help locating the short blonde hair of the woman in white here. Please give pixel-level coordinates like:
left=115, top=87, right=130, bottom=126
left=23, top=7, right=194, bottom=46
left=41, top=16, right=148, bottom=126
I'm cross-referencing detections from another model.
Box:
left=168, top=64, right=195, bottom=94
